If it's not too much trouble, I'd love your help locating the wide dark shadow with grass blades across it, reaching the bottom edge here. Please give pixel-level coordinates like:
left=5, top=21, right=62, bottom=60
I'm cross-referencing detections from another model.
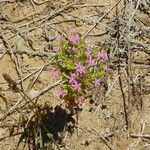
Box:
left=17, top=105, right=75, bottom=150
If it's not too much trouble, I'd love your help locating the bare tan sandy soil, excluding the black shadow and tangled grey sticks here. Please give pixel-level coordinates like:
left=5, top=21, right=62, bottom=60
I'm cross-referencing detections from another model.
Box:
left=0, top=0, right=150, bottom=150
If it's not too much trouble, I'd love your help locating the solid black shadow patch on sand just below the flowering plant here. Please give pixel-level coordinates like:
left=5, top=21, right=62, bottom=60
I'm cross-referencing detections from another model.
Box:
left=41, top=106, right=75, bottom=143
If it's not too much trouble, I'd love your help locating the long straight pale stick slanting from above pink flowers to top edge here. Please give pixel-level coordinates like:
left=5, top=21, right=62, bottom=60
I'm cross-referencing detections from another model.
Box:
left=82, top=0, right=121, bottom=38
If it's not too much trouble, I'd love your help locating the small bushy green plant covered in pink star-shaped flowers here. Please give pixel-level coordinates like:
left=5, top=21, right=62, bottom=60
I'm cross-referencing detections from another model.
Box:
left=50, top=29, right=110, bottom=108
